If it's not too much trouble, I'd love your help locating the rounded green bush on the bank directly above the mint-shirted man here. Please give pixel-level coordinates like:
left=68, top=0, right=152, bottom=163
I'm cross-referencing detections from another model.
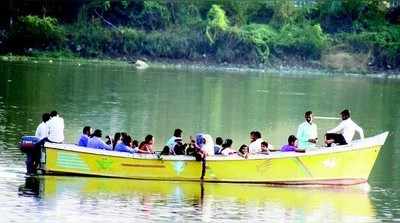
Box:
left=274, top=24, right=328, bottom=59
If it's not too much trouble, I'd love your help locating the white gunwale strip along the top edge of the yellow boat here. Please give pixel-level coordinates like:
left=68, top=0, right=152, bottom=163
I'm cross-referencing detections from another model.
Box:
left=45, top=132, right=389, bottom=161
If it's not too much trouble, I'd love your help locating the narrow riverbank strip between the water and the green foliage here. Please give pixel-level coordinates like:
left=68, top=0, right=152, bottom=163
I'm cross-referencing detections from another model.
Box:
left=0, top=54, right=400, bottom=79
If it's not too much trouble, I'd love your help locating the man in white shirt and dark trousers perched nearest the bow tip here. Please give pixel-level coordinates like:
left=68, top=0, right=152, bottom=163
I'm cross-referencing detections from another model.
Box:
left=325, top=109, right=364, bottom=147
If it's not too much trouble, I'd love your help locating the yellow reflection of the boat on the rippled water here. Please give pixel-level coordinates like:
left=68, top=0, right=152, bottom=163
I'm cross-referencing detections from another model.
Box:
left=20, top=176, right=376, bottom=222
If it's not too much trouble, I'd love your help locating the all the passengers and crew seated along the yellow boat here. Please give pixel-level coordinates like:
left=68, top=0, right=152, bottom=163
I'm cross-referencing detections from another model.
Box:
left=27, top=109, right=364, bottom=164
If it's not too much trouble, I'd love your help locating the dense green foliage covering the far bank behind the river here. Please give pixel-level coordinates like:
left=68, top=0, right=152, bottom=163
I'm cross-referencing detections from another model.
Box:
left=0, top=0, right=400, bottom=68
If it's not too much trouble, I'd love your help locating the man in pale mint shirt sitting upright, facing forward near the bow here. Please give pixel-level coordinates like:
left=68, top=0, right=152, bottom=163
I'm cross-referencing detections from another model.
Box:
left=297, top=111, right=318, bottom=150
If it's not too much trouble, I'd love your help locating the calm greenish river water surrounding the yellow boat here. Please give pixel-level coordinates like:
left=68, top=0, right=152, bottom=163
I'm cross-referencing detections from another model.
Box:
left=0, top=62, right=400, bottom=222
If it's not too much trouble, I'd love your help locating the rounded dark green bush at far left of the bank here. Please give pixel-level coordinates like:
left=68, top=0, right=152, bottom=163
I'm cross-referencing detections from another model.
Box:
left=9, top=15, right=65, bottom=49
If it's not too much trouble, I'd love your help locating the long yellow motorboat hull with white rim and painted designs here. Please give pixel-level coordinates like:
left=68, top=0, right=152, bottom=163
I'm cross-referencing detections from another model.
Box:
left=44, top=132, right=388, bottom=185
